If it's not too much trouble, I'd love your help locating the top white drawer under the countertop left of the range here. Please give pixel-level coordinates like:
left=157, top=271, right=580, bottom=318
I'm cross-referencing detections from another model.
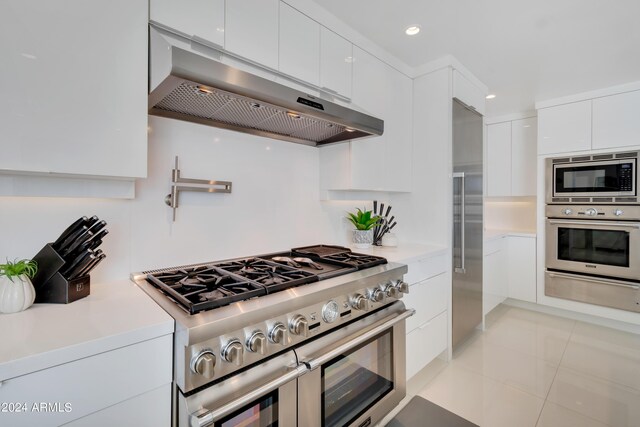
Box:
left=0, top=335, right=173, bottom=427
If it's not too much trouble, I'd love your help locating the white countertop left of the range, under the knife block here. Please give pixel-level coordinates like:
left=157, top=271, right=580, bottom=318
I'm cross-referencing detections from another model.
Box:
left=0, top=280, right=174, bottom=381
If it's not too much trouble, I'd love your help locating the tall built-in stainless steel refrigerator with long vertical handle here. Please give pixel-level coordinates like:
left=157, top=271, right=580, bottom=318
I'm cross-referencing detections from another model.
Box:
left=451, top=99, right=483, bottom=349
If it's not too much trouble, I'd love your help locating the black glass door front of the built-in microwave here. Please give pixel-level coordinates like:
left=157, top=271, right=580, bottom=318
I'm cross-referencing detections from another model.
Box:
left=554, top=161, right=635, bottom=195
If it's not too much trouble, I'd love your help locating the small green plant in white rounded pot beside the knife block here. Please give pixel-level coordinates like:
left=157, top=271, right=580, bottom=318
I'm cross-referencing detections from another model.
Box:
left=0, top=259, right=38, bottom=313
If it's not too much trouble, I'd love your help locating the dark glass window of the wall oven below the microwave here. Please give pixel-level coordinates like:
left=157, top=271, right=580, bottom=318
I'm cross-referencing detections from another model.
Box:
left=558, top=227, right=629, bottom=267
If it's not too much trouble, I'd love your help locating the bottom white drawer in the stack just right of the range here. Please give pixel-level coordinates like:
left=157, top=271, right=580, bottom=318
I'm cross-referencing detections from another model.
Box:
left=407, top=311, right=447, bottom=380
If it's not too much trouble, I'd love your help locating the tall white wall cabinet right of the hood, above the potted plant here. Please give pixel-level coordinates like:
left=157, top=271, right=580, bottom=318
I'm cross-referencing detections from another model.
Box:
left=321, top=46, right=413, bottom=191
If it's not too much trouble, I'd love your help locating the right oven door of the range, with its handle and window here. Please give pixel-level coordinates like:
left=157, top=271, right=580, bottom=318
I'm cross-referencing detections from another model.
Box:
left=296, top=301, right=414, bottom=427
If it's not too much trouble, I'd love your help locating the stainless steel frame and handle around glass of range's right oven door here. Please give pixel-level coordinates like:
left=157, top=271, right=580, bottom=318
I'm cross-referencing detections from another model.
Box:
left=296, top=302, right=413, bottom=427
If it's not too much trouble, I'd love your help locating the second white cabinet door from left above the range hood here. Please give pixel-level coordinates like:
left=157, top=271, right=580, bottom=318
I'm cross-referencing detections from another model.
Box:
left=224, top=0, right=280, bottom=70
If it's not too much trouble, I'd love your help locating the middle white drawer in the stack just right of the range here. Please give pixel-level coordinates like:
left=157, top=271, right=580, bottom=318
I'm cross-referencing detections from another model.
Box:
left=403, top=273, right=450, bottom=331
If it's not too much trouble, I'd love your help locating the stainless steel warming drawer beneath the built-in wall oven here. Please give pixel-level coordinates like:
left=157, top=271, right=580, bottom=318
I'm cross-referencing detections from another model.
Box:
left=544, top=271, right=640, bottom=313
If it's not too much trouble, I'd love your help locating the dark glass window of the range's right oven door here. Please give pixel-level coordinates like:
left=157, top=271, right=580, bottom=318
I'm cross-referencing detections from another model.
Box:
left=321, top=329, right=394, bottom=427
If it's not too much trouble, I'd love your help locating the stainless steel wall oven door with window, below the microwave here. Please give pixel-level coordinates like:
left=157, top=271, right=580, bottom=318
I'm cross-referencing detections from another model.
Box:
left=546, top=219, right=640, bottom=280
